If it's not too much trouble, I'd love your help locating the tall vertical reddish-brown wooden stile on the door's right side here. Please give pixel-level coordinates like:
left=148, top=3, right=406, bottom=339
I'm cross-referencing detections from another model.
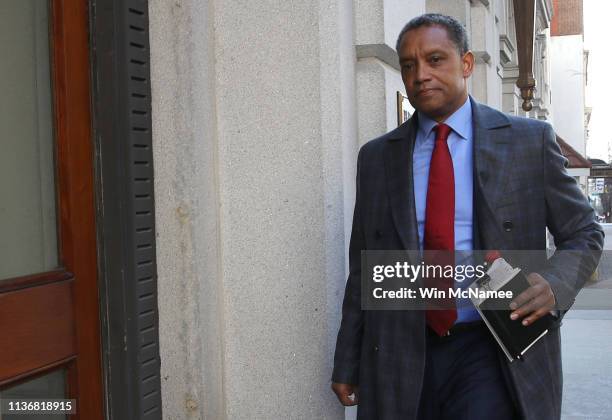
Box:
left=50, top=0, right=104, bottom=414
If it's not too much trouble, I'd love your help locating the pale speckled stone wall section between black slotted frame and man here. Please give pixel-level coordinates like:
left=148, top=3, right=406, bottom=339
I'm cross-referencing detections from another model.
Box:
left=149, top=0, right=357, bottom=419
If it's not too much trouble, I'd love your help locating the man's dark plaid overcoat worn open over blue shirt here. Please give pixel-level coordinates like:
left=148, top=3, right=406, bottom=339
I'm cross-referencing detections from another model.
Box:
left=332, top=97, right=603, bottom=420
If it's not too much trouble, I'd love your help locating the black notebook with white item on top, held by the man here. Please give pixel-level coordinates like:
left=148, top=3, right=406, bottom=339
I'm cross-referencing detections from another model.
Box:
left=470, top=258, right=555, bottom=361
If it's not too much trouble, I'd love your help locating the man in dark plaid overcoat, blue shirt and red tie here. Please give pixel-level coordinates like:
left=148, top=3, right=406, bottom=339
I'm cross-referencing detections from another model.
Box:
left=332, top=14, right=603, bottom=420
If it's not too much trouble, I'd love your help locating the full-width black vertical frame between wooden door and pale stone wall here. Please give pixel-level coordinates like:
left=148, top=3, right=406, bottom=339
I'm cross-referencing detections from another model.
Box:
left=90, top=0, right=162, bottom=420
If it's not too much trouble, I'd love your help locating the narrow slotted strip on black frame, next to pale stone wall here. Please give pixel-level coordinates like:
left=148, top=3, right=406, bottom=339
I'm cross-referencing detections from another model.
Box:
left=125, top=4, right=161, bottom=419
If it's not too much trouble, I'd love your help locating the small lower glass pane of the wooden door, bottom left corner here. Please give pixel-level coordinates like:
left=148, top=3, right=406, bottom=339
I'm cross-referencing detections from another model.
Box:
left=0, top=369, right=68, bottom=420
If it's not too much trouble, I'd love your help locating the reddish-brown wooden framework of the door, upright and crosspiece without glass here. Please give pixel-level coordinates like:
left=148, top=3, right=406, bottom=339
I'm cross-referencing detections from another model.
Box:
left=0, top=0, right=104, bottom=420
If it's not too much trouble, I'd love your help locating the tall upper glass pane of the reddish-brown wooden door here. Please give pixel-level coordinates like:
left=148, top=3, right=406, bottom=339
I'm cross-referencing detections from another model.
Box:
left=0, top=0, right=58, bottom=279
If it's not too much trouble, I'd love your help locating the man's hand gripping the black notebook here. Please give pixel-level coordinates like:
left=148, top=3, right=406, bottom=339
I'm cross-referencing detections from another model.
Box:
left=510, top=273, right=556, bottom=326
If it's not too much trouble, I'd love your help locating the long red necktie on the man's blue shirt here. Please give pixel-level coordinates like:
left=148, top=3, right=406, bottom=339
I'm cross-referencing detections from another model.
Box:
left=423, top=124, right=457, bottom=335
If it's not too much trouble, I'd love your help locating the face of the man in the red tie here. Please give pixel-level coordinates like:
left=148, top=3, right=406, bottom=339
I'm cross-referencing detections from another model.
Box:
left=398, top=25, right=474, bottom=122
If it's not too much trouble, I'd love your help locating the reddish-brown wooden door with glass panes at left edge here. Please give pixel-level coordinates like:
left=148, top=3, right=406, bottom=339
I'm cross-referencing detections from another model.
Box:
left=0, top=0, right=103, bottom=420
